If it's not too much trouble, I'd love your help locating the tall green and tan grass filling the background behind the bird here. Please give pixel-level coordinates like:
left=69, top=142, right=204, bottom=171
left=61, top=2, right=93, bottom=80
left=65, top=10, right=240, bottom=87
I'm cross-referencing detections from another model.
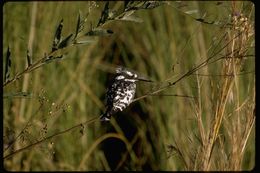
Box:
left=3, top=1, right=255, bottom=171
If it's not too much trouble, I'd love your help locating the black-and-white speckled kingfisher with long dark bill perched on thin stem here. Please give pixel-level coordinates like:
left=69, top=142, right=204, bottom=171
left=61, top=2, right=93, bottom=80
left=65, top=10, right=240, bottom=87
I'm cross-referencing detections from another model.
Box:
left=100, top=67, right=152, bottom=121
